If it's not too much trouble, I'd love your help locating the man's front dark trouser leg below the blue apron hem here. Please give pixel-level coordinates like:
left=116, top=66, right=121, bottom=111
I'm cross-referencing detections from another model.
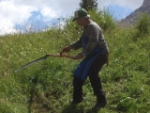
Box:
left=73, top=76, right=84, bottom=103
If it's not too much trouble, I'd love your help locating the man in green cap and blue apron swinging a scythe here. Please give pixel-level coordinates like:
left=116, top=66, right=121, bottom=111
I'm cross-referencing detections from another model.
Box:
left=62, top=8, right=109, bottom=108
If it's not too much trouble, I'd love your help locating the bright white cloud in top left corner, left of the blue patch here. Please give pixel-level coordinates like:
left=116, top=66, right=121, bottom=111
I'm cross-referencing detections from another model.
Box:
left=0, top=1, right=33, bottom=34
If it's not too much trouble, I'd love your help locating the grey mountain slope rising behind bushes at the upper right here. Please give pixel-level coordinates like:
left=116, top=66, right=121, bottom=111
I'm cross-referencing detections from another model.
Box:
left=119, top=0, right=150, bottom=27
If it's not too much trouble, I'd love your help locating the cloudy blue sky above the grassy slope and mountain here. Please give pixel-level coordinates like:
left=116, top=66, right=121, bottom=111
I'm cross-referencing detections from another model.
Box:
left=0, top=0, right=143, bottom=35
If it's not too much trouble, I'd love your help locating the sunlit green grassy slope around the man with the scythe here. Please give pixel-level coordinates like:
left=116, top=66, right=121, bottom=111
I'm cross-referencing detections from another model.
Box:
left=0, top=13, right=150, bottom=113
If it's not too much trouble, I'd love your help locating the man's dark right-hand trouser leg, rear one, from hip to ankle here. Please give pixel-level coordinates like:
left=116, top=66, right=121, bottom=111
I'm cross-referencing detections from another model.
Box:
left=88, top=54, right=107, bottom=102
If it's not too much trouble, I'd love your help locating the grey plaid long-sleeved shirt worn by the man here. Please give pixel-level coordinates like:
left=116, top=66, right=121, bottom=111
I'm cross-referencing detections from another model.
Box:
left=71, top=20, right=109, bottom=56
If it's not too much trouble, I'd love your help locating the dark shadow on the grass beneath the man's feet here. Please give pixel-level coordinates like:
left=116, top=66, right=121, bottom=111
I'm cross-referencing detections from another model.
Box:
left=61, top=104, right=99, bottom=113
